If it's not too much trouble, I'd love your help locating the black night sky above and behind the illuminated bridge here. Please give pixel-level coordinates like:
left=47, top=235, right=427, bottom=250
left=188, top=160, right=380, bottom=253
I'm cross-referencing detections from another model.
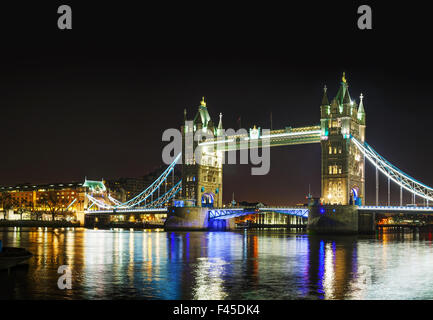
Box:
left=0, top=1, right=433, bottom=204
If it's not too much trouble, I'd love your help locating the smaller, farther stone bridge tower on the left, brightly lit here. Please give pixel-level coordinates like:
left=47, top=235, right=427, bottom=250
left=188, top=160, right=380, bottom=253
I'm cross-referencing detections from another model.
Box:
left=181, top=97, right=224, bottom=207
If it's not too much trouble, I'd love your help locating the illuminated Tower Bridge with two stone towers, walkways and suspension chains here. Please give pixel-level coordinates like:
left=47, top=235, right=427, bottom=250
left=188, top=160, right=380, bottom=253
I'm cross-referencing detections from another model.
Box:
left=87, top=73, right=433, bottom=232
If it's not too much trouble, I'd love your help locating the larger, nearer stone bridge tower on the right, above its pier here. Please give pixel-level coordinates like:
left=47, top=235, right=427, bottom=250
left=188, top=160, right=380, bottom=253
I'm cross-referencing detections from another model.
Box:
left=320, top=73, right=365, bottom=205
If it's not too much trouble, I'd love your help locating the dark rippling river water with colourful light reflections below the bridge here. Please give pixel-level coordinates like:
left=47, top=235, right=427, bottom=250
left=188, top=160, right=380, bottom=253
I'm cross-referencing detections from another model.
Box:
left=0, top=228, right=433, bottom=299
